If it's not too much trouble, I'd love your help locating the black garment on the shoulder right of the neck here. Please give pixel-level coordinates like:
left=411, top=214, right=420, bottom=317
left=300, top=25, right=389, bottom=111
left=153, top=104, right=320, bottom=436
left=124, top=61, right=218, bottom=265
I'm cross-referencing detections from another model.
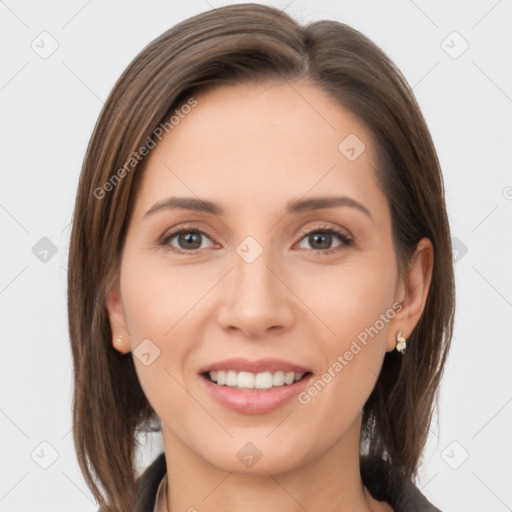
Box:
left=361, top=456, right=441, bottom=512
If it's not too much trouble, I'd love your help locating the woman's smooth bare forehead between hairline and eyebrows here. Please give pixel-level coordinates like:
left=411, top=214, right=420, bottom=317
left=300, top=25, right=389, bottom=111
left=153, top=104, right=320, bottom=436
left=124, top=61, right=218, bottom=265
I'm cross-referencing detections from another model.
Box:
left=136, top=82, right=384, bottom=221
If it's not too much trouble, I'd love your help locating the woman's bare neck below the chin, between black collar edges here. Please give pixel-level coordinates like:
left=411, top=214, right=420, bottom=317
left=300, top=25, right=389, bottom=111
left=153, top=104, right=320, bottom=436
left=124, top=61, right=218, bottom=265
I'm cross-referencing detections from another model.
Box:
left=162, top=416, right=391, bottom=512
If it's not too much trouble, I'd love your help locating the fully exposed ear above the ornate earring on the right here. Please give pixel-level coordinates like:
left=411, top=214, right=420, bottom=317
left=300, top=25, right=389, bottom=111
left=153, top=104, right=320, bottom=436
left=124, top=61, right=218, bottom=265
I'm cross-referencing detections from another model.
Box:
left=386, top=238, right=434, bottom=352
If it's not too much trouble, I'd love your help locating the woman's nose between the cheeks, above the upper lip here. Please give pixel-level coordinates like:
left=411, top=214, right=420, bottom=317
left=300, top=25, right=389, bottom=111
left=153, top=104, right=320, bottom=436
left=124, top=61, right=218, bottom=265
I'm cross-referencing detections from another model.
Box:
left=218, top=247, right=294, bottom=339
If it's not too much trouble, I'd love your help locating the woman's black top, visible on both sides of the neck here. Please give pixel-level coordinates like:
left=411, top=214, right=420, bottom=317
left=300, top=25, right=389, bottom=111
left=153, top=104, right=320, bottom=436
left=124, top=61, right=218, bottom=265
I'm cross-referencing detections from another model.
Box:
left=133, top=452, right=441, bottom=512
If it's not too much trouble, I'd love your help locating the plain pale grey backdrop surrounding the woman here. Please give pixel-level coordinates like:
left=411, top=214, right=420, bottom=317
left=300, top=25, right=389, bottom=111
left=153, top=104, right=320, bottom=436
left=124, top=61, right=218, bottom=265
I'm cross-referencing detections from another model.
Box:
left=0, top=0, right=512, bottom=512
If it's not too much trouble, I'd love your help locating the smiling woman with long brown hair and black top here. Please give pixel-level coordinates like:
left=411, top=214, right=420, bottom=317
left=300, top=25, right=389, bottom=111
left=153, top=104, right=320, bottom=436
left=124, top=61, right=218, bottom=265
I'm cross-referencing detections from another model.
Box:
left=68, top=4, right=455, bottom=512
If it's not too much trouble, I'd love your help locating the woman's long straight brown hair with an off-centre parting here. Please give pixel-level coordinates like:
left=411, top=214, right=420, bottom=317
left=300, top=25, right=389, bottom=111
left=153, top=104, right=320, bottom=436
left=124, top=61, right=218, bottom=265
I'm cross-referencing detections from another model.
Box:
left=68, top=4, right=455, bottom=512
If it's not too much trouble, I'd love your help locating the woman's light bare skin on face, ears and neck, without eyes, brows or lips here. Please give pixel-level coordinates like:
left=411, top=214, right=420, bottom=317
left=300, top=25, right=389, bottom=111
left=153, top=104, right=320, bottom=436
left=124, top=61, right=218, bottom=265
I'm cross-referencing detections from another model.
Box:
left=108, top=82, right=433, bottom=512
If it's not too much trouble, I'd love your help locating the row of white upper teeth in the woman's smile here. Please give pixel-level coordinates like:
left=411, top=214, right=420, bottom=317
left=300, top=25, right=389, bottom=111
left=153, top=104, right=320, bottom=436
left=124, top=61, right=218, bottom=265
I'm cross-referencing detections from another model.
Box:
left=208, top=370, right=304, bottom=389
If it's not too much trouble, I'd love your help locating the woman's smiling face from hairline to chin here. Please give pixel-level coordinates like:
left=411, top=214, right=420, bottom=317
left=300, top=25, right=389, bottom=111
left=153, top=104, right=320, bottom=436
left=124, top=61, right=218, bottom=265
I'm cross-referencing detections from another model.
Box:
left=108, top=83, right=428, bottom=472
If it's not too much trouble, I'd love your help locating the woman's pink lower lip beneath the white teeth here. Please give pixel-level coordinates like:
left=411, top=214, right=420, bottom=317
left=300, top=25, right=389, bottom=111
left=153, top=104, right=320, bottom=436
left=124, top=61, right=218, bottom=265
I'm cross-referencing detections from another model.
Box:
left=200, top=374, right=312, bottom=414
